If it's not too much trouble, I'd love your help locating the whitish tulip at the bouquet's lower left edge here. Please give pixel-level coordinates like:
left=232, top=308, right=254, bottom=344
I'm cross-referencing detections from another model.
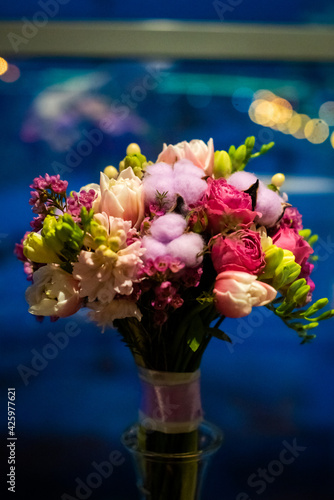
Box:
left=26, top=264, right=81, bottom=318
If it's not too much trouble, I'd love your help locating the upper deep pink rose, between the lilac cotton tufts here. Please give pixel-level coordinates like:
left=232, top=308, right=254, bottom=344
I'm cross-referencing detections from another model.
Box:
left=203, top=178, right=258, bottom=234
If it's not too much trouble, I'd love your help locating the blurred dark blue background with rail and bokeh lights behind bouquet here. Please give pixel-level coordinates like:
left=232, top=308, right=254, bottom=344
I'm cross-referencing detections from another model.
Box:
left=0, top=0, right=334, bottom=500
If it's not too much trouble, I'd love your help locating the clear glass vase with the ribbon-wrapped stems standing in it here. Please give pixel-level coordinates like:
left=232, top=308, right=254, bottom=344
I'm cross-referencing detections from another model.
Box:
left=122, top=369, right=222, bottom=500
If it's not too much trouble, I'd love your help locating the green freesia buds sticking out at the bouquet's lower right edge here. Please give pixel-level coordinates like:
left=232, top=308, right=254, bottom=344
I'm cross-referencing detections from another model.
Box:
left=267, top=279, right=334, bottom=344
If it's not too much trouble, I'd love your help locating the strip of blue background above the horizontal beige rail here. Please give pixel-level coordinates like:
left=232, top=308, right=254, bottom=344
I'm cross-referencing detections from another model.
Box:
left=0, top=0, right=334, bottom=24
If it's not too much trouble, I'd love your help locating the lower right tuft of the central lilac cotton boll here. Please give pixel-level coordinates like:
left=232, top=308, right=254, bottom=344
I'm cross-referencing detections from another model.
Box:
left=167, top=233, right=204, bottom=267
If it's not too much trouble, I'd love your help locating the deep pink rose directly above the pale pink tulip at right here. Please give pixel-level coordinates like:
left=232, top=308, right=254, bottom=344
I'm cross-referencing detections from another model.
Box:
left=211, top=229, right=266, bottom=275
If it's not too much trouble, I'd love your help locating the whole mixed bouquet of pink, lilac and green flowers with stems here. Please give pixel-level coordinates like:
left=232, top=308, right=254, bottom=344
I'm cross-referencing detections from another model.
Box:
left=16, top=137, right=334, bottom=499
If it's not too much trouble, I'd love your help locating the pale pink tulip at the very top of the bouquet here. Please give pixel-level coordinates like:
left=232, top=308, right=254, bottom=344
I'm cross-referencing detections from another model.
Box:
left=157, top=139, right=214, bottom=175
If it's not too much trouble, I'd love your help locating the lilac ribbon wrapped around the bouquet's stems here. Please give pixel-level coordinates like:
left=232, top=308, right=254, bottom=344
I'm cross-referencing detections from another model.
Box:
left=139, top=367, right=203, bottom=434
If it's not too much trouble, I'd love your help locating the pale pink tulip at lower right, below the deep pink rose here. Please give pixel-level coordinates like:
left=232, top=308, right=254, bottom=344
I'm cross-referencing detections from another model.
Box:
left=213, top=271, right=277, bottom=318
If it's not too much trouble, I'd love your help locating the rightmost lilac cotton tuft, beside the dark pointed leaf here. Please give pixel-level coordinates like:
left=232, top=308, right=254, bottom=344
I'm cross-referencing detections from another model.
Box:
left=255, top=182, right=283, bottom=227
